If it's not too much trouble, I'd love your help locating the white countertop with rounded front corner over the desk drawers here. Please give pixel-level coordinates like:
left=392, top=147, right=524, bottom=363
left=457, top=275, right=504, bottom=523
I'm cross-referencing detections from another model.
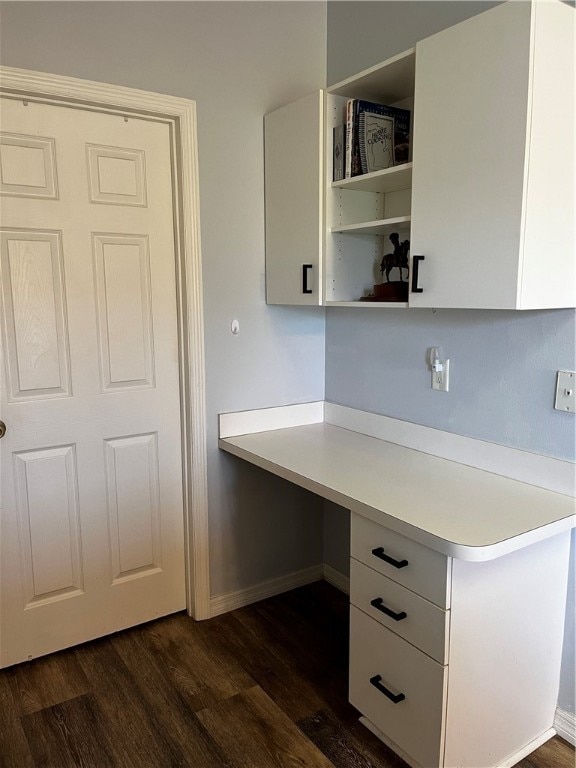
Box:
left=219, top=423, right=576, bottom=561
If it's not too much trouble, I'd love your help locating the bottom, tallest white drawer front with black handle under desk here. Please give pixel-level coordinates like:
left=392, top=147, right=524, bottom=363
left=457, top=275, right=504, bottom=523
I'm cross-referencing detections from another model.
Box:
left=350, top=606, right=448, bottom=768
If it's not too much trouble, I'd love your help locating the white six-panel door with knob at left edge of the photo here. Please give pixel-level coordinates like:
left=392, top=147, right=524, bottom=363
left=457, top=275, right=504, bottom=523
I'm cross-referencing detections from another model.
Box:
left=0, top=98, right=185, bottom=666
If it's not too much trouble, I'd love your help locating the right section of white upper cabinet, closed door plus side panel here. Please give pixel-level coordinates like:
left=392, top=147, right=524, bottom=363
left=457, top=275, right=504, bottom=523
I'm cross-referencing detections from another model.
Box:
left=410, top=0, right=576, bottom=309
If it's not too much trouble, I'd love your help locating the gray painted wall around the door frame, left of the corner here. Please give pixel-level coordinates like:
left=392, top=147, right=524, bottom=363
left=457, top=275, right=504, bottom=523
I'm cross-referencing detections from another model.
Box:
left=1, top=2, right=326, bottom=595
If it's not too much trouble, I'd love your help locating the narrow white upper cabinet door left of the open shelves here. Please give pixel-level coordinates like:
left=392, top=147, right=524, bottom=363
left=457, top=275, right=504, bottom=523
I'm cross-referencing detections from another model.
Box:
left=264, top=91, right=324, bottom=305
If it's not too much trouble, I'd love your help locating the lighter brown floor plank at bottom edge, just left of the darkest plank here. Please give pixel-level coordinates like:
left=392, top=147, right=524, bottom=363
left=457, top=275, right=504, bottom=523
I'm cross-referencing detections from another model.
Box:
left=198, top=686, right=333, bottom=768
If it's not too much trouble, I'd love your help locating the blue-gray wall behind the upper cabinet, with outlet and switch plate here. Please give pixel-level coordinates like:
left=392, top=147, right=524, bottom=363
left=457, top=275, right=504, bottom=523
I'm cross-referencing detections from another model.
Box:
left=324, top=0, right=576, bottom=712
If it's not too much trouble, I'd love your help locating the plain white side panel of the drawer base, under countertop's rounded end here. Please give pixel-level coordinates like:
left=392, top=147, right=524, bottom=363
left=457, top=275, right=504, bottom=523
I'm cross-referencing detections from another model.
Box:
left=445, top=533, right=570, bottom=768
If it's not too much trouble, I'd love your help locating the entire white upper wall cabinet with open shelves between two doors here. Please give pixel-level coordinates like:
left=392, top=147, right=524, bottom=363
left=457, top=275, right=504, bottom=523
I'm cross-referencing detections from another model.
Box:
left=265, top=0, right=576, bottom=309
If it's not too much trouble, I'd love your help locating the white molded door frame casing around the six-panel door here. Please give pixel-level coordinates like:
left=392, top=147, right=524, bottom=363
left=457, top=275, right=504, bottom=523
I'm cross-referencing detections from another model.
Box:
left=0, top=66, right=210, bottom=619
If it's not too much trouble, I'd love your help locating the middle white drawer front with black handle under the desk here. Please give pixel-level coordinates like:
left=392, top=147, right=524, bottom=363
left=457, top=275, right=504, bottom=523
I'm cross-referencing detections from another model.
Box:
left=350, top=558, right=450, bottom=664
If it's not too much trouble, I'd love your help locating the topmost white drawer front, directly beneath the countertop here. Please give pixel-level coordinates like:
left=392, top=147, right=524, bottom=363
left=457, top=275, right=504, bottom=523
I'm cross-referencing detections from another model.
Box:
left=350, top=514, right=451, bottom=608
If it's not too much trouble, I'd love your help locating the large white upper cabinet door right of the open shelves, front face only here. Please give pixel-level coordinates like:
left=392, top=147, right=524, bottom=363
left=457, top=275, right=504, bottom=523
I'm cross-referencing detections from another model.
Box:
left=410, top=3, right=531, bottom=309
